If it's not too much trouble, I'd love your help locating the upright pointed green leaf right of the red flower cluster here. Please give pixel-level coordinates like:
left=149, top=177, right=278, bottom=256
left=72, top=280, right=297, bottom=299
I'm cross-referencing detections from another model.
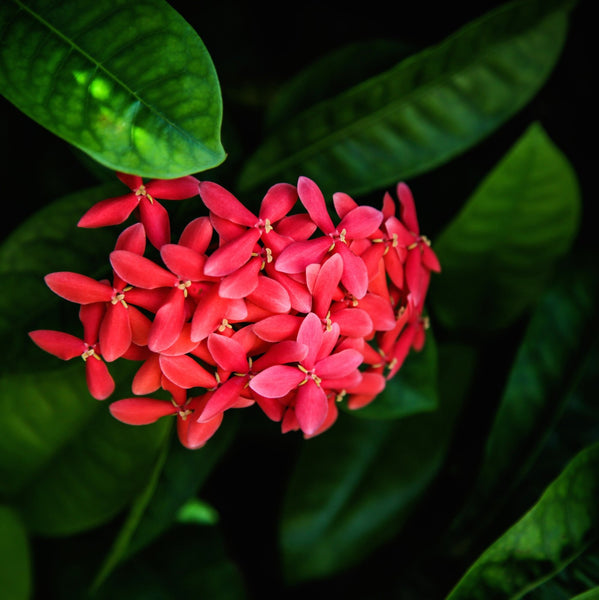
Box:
left=430, top=123, right=580, bottom=332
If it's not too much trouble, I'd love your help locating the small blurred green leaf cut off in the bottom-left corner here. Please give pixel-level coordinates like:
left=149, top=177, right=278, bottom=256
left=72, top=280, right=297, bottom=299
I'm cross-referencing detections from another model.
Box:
left=0, top=505, right=32, bottom=600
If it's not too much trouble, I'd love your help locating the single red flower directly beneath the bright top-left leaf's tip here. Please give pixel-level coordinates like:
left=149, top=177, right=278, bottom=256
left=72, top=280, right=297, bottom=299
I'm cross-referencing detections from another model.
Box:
left=77, top=173, right=199, bottom=248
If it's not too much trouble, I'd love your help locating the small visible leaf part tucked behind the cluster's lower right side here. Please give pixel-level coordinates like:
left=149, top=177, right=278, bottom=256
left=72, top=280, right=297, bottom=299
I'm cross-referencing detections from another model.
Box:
left=347, top=330, right=438, bottom=419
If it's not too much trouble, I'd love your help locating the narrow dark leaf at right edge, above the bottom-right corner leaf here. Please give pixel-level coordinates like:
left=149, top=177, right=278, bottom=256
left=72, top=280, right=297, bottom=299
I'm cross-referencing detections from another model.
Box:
left=474, top=266, right=599, bottom=520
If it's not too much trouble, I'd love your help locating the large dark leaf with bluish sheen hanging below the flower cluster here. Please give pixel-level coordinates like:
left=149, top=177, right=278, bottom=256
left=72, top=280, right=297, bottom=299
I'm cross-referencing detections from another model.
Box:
left=280, top=340, right=471, bottom=583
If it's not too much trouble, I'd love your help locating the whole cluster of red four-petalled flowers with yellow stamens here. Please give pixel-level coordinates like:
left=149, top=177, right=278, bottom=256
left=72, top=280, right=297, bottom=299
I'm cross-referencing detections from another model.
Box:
left=30, top=174, right=440, bottom=448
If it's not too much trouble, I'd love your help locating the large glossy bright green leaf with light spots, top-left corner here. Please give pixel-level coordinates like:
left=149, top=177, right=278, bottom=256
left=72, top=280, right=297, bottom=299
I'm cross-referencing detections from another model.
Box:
left=0, top=0, right=225, bottom=178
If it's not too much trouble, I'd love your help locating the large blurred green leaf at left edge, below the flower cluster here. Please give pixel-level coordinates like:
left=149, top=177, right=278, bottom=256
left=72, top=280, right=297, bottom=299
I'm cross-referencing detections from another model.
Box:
left=5, top=364, right=171, bottom=535
